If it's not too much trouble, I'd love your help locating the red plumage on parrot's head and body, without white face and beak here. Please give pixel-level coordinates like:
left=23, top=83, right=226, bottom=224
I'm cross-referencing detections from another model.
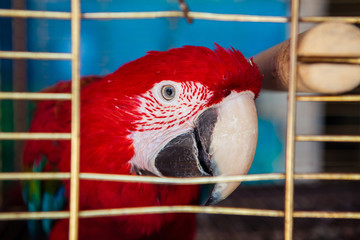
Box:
left=23, top=45, right=261, bottom=239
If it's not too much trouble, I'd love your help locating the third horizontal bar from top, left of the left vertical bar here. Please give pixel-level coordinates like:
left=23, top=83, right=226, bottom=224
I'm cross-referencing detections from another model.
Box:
left=0, top=92, right=71, bottom=100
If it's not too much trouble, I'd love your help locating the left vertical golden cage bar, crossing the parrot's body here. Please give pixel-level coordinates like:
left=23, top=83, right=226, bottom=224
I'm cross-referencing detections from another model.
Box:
left=69, top=0, right=81, bottom=240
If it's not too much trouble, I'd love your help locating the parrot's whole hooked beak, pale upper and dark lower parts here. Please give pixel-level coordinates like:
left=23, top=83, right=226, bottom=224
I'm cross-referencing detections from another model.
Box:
left=155, top=91, right=258, bottom=204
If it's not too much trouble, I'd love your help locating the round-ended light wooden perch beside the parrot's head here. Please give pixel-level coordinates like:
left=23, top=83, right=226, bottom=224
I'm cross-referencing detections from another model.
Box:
left=254, top=22, right=360, bottom=94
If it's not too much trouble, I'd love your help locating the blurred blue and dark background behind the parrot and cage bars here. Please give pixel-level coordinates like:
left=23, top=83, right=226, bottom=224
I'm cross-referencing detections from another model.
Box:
left=0, top=0, right=360, bottom=239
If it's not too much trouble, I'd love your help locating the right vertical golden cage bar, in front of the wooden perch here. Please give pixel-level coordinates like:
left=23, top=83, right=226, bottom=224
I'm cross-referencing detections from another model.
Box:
left=284, top=0, right=299, bottom=240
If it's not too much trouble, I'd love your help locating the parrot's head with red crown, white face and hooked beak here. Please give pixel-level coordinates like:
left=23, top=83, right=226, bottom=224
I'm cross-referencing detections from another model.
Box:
left=87, top=45, right=262, bottom=204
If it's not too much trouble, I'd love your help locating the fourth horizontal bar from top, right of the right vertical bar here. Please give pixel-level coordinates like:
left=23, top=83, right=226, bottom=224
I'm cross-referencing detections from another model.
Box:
left=295, top=135, right=360, bottom=142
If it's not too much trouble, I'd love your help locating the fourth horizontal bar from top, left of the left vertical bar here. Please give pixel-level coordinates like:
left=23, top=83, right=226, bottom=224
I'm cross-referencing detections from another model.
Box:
left=0, top=132, right=71, bottom=140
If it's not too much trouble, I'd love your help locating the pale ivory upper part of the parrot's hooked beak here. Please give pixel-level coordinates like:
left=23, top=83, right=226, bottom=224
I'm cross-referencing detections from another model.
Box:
left=207, top=92, right=258, bottom=204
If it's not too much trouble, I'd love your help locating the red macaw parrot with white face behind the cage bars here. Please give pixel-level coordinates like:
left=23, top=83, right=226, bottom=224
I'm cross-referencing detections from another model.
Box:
left=23, top=45, right=262, bottom=240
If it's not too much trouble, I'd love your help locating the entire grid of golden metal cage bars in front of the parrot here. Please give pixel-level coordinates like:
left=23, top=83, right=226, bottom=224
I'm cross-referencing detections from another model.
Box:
left=0, top=0, right=360, bottom=240
